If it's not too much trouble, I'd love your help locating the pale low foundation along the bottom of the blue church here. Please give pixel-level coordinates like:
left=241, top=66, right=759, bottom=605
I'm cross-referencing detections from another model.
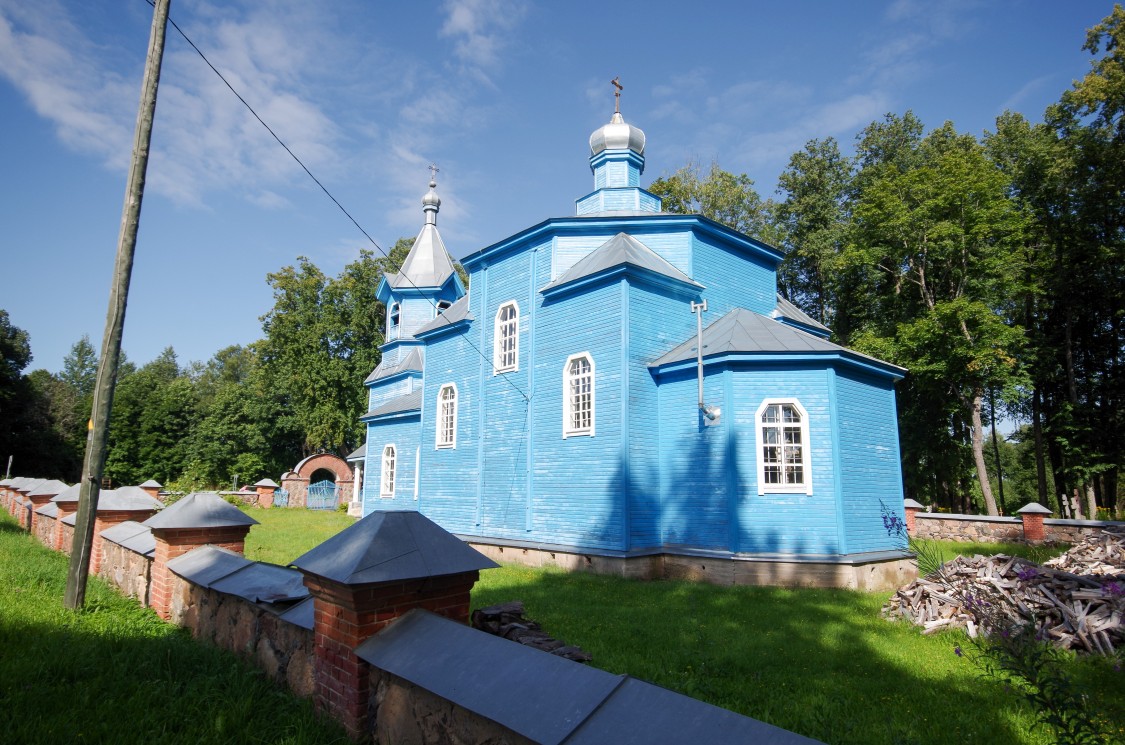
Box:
left=461, top=536, right=918, bottom=592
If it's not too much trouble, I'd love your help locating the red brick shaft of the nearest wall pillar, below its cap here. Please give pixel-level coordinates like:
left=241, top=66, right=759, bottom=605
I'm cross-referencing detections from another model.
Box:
left=301, top=571, right=480, bottom=739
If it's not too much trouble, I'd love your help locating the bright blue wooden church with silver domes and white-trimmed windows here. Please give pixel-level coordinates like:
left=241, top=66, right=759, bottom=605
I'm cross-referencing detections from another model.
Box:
left=362, top=99, right=910, bottom=587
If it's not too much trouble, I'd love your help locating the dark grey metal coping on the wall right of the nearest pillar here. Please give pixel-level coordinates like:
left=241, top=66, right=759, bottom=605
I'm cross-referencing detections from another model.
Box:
left=356, top=610, right=816, bottom=745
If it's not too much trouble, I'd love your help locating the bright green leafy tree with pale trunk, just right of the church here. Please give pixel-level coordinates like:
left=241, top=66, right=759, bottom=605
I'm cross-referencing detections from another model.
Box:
left=847, top=123, right=1023, bottom=514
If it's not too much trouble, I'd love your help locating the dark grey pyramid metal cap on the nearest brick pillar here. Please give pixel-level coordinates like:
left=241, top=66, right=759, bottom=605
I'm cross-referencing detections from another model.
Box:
left=293, top=510, right=498, bottom=584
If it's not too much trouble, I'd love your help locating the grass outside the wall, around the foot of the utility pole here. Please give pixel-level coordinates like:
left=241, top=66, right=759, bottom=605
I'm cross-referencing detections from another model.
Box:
left=0, top=514, right=348, bottom=745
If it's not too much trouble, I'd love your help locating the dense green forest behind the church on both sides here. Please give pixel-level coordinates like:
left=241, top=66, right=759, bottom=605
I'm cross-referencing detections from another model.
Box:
left=0, top=6, right=1125, bottom=518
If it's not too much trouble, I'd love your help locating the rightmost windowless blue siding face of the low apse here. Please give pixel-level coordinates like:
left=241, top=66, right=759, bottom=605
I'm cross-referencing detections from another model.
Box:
left=836, top=373, right=906, bottom=553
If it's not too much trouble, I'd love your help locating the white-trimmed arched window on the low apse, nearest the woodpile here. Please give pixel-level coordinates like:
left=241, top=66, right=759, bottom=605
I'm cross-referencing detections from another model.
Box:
left=755, top=398, right=812, bottom=494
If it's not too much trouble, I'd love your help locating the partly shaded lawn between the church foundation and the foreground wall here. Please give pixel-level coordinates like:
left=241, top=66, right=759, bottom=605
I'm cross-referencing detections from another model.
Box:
left=474, top=567, right=1125, bottom=745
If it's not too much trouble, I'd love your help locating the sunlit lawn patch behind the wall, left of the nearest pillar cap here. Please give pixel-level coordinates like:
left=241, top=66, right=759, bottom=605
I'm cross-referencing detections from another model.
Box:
left=242, top=506, right=356, bottom=566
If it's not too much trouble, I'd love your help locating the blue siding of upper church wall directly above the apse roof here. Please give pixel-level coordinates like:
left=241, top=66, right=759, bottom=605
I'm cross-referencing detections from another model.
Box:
left=693, top=235, right=777, bottom=318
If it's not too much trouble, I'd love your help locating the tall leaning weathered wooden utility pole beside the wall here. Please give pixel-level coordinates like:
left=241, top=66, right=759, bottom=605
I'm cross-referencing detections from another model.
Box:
left=63, top=0, right=171, bottom=609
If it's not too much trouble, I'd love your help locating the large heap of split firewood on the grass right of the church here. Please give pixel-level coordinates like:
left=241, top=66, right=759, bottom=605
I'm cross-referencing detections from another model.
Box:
left=883, top=531, right=1125, bottom=655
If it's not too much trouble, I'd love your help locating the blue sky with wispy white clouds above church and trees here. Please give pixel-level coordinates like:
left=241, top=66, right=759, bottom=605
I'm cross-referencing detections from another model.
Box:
left=0, top=0, right=1113, bottom=371
